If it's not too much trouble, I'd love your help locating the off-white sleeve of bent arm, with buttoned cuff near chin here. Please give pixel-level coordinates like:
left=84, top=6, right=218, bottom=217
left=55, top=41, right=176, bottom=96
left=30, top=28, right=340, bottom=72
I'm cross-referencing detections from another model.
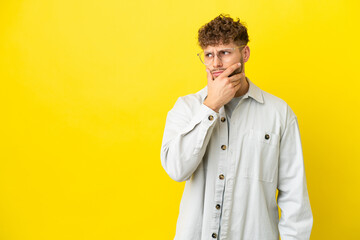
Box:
left=160, top=97, right=219, bottom=182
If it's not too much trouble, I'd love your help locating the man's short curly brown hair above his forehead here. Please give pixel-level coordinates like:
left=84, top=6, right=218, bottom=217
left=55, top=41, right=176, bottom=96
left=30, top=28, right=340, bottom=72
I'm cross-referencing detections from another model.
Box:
left=198, top=14, right=249, bottom=49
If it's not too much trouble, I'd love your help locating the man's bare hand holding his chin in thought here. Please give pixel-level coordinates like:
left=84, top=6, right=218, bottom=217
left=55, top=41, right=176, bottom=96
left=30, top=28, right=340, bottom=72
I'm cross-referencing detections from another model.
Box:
left=204, top=63, right=245, bottom=112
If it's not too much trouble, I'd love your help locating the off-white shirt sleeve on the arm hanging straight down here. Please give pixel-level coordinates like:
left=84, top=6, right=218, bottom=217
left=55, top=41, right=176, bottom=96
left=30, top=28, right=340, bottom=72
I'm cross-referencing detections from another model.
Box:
left=277, top=106, right=313, bottom=240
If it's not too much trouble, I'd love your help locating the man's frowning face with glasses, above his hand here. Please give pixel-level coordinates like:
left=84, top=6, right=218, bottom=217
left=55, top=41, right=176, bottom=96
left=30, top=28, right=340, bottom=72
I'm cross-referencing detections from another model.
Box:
left=204, top=43, right=247, bottom=78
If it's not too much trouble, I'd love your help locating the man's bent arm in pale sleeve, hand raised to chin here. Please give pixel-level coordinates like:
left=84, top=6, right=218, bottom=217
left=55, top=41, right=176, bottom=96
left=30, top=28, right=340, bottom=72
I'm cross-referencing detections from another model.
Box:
left=161, top=63, right=245, bottom=182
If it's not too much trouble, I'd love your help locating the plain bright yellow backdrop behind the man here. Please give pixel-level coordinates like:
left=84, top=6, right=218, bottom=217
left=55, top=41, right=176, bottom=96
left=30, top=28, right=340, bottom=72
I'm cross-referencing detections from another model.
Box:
left=0, top=0, right=360, bottom=240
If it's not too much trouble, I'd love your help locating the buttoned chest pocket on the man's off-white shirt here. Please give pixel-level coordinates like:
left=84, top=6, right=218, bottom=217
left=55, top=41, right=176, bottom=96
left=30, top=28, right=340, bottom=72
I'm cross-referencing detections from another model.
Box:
left=240, top=129, right=280, bottom=182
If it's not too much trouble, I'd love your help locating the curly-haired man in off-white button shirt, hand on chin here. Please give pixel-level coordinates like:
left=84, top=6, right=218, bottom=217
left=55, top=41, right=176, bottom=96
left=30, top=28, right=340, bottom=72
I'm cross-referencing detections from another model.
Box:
left=161, top=14, right=313, bottom=240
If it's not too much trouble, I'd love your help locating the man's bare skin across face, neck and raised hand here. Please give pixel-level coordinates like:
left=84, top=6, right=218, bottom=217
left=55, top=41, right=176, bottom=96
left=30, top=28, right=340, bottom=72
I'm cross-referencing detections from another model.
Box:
left=203, top=42, right=250, bottom=112
